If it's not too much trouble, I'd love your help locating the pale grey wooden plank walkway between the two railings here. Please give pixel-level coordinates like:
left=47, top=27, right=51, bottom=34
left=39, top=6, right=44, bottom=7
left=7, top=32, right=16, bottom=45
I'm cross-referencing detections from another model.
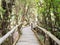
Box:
left=16, top=26, right=40, bottom=45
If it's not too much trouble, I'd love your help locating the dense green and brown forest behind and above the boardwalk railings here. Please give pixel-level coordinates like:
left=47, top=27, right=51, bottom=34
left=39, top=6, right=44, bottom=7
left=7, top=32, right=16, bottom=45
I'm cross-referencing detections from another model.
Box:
left=0, top=0, right=60, bottom=44
